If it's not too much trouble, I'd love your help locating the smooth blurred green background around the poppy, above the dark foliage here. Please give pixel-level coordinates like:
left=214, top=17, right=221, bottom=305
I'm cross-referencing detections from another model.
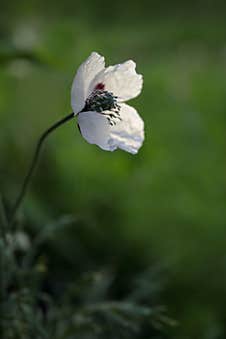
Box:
left=0, top=0, right=226, bottom=339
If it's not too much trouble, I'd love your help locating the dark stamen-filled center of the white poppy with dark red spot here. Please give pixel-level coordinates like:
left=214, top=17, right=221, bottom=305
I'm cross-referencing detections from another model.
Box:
left=82, top=84, right=121, bottom=126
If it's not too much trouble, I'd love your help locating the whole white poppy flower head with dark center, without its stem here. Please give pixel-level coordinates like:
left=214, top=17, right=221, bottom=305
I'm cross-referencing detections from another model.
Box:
left=71, top=52, right=144, bottom=154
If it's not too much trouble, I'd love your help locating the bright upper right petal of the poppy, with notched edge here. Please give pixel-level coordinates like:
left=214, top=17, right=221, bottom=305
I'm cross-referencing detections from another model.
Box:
left=90, top=60, right=143, bottom=101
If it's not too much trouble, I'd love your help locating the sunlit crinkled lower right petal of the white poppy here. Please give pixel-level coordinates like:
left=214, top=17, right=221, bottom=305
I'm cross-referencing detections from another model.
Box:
left=108, top=104, right=144, bottom=154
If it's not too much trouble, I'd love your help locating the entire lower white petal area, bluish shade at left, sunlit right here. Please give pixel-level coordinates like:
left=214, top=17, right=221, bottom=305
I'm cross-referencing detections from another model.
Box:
left=78, top=104, right=144, bottom=154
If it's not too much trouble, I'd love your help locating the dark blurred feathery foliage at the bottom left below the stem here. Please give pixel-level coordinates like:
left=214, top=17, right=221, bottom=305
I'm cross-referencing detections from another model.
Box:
left=0, top=204, right=175, bottom=339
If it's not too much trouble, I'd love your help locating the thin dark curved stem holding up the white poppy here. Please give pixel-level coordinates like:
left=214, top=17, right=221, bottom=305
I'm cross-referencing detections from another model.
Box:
left=10, top=113, right=75, bottom=224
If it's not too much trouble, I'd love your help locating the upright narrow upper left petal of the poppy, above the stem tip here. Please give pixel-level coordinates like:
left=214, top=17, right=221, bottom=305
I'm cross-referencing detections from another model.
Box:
left=71, top=52, right=105, bottom=114
